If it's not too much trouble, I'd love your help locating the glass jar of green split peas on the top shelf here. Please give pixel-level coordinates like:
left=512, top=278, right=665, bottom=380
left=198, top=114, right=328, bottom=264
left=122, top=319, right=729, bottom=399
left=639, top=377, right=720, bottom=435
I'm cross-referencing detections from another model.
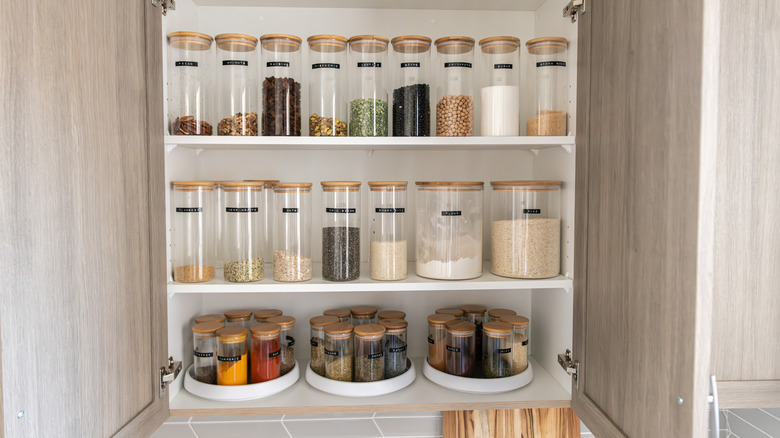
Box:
left=349, top=35, right=389, bottom=137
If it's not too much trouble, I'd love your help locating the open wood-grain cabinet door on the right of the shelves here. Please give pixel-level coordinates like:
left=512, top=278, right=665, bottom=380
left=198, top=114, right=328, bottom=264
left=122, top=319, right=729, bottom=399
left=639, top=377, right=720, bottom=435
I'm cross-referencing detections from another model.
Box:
left=572, top=0, right=711, bottom=438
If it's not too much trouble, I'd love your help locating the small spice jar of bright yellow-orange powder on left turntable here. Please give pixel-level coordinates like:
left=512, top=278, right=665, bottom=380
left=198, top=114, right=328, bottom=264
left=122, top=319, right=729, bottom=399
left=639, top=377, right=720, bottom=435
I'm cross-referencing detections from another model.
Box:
left=217, top=327, right=249, bottom=385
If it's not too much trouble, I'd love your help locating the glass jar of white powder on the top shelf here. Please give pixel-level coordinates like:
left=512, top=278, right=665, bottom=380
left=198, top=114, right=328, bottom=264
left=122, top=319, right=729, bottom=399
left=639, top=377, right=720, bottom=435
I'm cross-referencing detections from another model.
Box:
left=479, top=36, right=520, bottom=136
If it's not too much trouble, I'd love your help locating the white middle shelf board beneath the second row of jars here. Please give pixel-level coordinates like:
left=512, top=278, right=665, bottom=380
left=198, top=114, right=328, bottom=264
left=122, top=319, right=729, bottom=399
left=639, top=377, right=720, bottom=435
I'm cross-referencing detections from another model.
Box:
left=168, top=262, right=573, bottom=295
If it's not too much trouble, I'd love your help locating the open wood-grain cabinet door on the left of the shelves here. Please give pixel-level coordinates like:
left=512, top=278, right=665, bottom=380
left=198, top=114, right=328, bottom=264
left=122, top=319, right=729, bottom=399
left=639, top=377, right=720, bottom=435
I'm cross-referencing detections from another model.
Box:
left=0, top=0, right=168, bottom=438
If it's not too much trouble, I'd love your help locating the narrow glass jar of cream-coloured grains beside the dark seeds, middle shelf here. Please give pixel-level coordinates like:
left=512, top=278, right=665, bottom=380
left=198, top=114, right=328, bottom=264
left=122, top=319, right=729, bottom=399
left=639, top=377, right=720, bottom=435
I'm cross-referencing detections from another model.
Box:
left=368, top=181, right=408, bottom=281
